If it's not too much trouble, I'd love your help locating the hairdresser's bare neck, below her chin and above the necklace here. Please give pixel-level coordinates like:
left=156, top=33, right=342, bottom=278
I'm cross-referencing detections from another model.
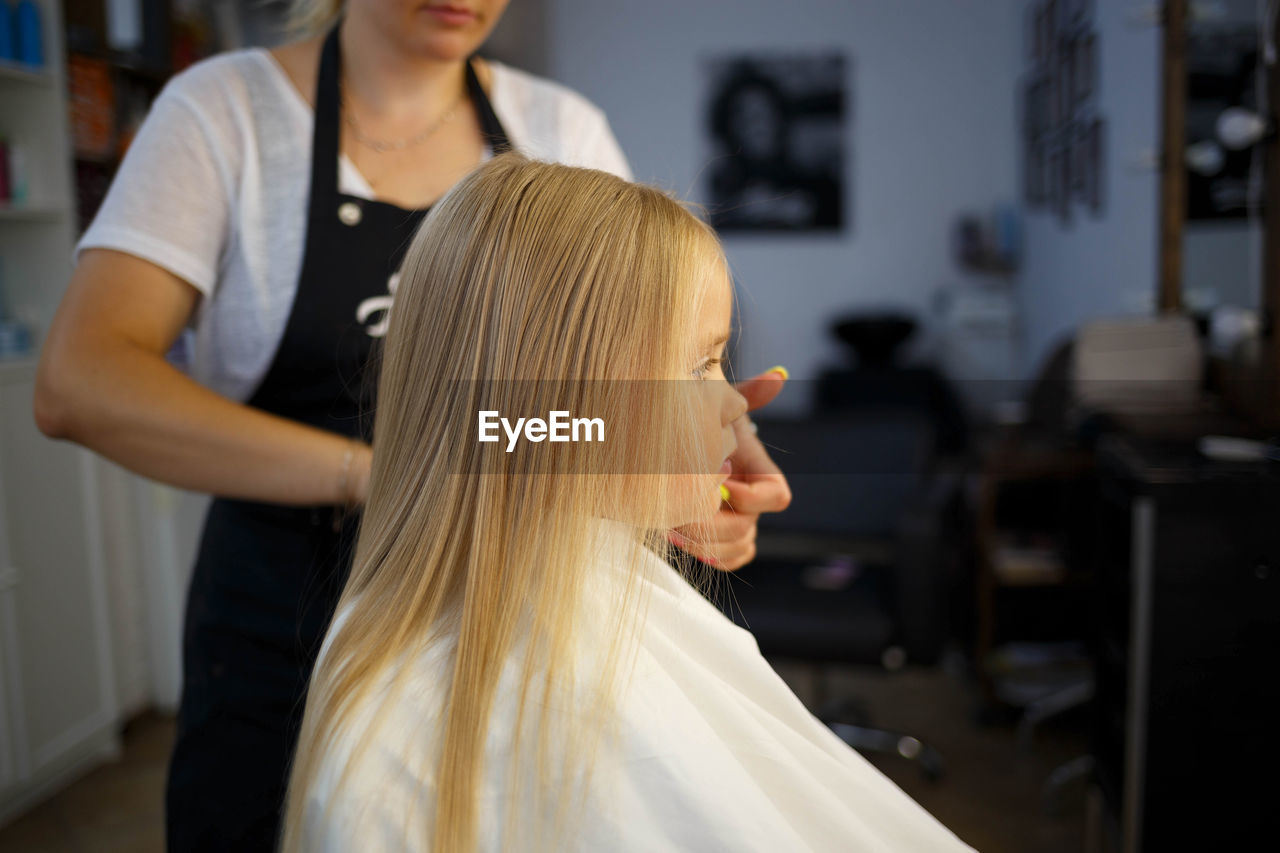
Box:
left=338, top=8, right=466, bottom=115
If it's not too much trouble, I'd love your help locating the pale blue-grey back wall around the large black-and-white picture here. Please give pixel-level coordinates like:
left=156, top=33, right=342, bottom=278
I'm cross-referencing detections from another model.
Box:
left=545, top=0, right=1021, bottom=405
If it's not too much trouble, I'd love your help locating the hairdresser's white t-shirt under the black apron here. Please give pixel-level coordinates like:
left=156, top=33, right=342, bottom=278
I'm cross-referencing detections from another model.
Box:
left=76, top=47, right=631, bottom=402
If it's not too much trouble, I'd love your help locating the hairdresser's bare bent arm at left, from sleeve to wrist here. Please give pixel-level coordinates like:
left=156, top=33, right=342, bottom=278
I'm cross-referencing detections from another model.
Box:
left=35, top=248, right=372, bottom=505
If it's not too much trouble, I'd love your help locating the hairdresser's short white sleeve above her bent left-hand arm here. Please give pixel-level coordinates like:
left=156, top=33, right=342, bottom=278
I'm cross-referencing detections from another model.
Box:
left=76, top=76, right=239, bottom=297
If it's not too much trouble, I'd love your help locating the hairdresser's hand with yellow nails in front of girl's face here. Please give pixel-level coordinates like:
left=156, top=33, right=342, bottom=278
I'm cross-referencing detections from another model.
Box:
left=671, top=368, right=791, bottom=571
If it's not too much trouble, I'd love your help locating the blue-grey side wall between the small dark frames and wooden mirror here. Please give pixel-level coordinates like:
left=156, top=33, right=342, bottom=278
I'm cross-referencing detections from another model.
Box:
left=1019, top=0, right=1161, bottom=369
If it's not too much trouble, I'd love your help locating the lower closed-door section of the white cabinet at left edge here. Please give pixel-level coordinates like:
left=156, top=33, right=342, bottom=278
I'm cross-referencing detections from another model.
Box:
left=0, top=362, right=119, bottom=822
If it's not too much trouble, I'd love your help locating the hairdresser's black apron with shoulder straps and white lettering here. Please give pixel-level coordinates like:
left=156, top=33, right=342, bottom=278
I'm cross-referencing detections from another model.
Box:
left=165, top=27, right=509, bottom=853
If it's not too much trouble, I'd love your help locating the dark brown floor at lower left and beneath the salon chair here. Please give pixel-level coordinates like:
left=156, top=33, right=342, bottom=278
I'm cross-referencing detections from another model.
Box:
left=0, top=663, right=1085, bottom=853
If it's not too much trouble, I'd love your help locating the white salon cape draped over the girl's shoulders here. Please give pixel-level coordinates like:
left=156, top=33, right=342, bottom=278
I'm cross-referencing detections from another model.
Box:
left=303, top=521, right=972, bottom=853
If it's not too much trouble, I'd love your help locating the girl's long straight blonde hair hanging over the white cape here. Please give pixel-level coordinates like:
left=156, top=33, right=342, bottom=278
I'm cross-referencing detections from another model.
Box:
left=283, top=154, right=726, bottom=853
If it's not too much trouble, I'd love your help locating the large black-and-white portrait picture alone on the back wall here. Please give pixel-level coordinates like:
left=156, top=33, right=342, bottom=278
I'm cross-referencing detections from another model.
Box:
left=703, top=53, right=849, bottom=232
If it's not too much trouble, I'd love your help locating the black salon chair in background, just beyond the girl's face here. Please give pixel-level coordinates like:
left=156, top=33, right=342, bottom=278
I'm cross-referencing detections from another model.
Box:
left=718, top=409, right=956, bottom=777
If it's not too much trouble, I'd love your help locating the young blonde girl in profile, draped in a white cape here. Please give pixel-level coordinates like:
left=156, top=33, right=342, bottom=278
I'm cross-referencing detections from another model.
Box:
left=283, top=155, right=969, bottom=853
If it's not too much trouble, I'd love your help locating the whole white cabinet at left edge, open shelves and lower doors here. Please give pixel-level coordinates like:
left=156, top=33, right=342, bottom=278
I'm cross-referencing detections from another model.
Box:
left=0, top=0, right=119, bottom=824
